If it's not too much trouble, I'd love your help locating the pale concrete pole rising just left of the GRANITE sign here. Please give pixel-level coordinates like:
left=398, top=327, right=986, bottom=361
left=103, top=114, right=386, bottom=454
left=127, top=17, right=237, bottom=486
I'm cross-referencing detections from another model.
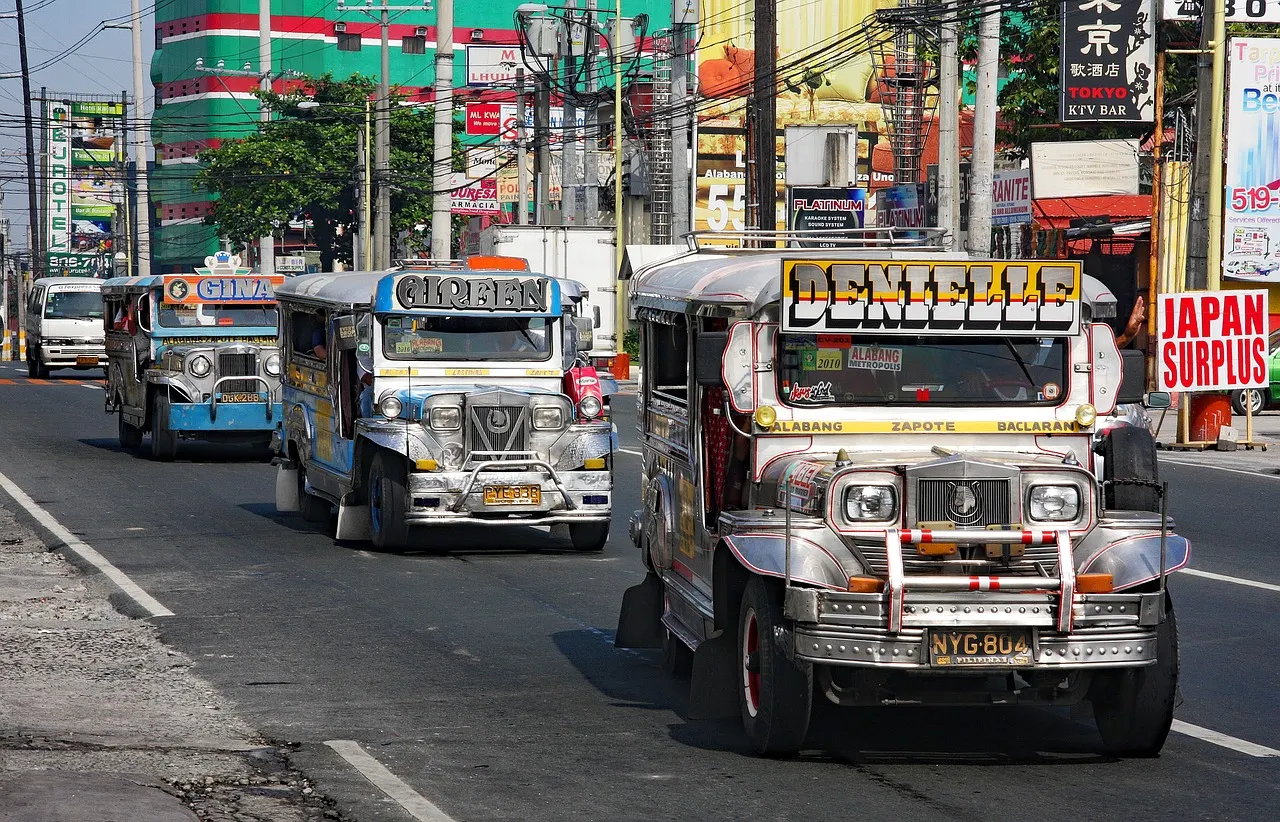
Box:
left=967, top=5, right=1001, bottom=256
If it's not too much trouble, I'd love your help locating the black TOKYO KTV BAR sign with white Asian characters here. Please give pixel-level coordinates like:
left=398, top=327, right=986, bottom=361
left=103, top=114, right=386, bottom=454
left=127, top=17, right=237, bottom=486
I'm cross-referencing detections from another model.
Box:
left=1059, top=0, right=1156, bottom=125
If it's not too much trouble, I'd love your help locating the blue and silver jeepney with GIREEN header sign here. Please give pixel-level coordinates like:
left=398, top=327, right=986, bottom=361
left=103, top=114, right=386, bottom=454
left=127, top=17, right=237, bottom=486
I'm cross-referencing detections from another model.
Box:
left=275, top=259, right=616, bottom=551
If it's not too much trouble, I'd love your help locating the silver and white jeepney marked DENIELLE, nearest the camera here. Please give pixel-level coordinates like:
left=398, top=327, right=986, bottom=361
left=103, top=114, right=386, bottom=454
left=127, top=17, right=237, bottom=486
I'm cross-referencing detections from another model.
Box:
left=617, top=234, right=1190, bottom=755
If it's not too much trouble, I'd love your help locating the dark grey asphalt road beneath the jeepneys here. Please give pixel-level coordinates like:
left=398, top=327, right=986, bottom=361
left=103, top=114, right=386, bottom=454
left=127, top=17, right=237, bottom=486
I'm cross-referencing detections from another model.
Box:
left=0, top=364, right=1280, bottom=822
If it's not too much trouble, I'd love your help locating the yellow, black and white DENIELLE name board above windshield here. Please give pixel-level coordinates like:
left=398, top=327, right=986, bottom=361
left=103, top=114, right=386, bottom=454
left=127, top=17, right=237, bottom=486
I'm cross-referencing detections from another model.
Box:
left=782, top=260, right=1080, bottom=337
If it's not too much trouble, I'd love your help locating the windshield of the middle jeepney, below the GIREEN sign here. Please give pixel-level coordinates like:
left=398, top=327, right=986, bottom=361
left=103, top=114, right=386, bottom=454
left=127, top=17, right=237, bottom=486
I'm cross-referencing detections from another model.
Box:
left=383, top=316, right=552, bottom=360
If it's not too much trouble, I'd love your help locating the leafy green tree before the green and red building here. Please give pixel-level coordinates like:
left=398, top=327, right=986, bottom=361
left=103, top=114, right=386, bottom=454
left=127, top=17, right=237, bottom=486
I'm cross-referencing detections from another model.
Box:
left=195, top=74, right=461, bottom=270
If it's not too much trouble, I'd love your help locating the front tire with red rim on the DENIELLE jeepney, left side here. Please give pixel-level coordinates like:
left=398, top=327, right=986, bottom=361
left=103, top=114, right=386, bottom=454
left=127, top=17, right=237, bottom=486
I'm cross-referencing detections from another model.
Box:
left=737, top=576, right=813, bottom=755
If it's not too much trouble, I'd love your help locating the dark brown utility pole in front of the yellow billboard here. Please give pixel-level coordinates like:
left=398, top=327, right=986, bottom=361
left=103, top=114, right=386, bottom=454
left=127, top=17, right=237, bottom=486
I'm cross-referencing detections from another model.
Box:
left=748, top=0, right=780, bottom=235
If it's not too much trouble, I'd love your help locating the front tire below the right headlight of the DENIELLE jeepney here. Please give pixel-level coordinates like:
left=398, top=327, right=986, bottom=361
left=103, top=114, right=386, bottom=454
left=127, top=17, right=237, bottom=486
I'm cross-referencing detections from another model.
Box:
left=1089, top=588, right=1178, bottom=757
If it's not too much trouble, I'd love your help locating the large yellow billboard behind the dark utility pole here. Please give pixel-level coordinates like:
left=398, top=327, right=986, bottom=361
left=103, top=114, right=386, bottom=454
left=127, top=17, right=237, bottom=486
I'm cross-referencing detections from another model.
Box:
left=701, top=0, right=892, bottom=238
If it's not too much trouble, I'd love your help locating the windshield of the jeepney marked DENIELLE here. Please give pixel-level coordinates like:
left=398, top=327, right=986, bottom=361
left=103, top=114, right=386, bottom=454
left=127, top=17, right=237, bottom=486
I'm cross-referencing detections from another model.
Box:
left=778, top=333, right=1069, bottom=407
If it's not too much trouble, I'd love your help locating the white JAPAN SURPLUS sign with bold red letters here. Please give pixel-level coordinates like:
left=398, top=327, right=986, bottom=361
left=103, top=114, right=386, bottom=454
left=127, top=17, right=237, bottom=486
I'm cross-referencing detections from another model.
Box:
left=1156, top=291, right=1270, bottom=392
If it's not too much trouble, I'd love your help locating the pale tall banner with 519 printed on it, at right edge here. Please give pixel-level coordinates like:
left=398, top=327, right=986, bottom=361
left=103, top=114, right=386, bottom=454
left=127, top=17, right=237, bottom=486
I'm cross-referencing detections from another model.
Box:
left=1222, top=37, right=1280, bottom=283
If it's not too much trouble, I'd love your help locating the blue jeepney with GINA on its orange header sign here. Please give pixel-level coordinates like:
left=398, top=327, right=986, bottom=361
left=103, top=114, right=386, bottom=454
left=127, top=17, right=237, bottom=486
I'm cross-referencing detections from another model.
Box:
left=102, top=254, right=284, bottom=461
